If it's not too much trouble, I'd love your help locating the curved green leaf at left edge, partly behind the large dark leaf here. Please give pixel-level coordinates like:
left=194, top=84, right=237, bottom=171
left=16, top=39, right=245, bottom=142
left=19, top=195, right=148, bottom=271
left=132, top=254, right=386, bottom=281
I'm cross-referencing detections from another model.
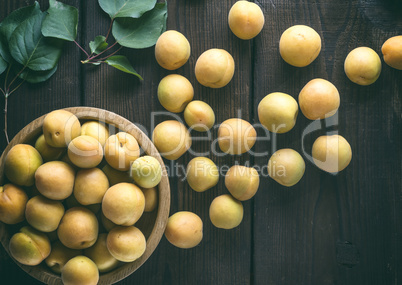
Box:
left=0, top=2, right=41, bottom=62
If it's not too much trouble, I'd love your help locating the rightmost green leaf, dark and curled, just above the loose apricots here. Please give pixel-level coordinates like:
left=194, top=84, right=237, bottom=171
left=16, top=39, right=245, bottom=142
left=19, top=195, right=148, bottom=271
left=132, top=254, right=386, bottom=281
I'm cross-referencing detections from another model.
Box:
left=112, top=3, right=167, bottom=49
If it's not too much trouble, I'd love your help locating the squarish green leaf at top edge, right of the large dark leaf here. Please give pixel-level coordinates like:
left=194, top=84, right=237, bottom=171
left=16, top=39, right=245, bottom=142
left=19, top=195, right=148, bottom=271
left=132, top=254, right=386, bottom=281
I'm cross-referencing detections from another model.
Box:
left=42, top=0, right=78, bottom=42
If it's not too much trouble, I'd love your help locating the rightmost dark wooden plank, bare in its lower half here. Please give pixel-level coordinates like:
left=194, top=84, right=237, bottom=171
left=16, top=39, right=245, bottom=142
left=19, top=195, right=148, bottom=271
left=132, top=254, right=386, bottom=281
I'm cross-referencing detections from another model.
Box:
left=253, top=0, right=402, bottom=284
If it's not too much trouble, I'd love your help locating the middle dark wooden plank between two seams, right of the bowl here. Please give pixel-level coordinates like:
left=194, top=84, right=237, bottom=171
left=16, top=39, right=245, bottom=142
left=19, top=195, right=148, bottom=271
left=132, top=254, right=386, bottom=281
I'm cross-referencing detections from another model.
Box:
left=84, top=0, right=252, bottom=284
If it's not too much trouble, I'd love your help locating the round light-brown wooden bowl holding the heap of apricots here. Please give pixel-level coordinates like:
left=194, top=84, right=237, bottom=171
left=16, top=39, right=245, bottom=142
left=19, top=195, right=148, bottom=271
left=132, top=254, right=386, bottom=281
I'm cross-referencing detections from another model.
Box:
left=0, top=107, right=170, bottom=284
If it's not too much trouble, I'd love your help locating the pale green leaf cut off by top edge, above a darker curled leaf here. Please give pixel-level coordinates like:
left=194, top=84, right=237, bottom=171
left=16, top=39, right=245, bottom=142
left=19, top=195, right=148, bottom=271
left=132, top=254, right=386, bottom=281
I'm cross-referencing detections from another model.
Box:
left=98, top=0, right=156, bottom=19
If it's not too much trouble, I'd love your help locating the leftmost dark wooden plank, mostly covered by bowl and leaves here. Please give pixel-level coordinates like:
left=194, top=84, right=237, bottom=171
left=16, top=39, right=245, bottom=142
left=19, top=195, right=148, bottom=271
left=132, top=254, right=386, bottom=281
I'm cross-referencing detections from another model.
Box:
left=0, top=0, right=81, bottom=284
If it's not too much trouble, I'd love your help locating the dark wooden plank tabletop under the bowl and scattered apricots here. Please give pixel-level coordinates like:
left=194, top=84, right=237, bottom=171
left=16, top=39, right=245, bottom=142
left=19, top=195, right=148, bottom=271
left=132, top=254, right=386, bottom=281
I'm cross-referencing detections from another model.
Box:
left=0, top=0, right=402, bottom=285
